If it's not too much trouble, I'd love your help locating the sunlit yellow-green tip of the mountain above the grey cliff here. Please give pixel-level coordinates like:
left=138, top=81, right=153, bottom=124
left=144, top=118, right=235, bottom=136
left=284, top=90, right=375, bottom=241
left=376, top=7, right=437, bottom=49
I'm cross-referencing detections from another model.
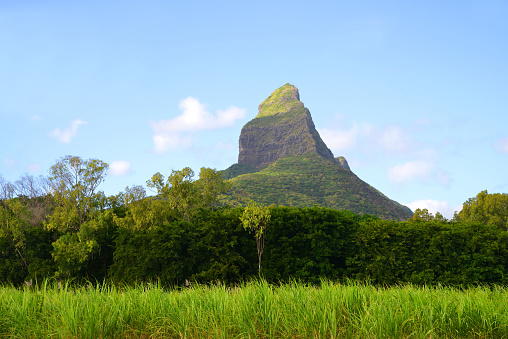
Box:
left=256, top=84, right=303, bottom=118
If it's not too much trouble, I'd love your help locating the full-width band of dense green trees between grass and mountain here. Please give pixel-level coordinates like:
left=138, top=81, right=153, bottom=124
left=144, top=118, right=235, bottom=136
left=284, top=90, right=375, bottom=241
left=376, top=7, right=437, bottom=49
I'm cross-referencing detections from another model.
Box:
left=0, top=156, right=508, bottom=286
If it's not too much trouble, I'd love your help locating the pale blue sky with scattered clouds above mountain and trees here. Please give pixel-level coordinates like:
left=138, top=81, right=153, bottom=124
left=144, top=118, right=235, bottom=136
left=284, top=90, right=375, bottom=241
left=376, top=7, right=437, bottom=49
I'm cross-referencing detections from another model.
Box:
left=0, top=0, right=508, bottom=217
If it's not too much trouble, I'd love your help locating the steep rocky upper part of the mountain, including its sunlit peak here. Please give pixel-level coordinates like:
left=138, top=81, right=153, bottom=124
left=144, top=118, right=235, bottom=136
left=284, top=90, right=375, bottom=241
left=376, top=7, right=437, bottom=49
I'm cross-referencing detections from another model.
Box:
left=238, top=84, right=338, bottom=167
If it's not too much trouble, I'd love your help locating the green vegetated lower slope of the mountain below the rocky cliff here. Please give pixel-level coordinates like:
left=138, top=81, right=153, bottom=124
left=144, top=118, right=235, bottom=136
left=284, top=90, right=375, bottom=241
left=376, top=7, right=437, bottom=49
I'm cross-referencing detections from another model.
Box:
left=221, top=153, right=412, bottom=220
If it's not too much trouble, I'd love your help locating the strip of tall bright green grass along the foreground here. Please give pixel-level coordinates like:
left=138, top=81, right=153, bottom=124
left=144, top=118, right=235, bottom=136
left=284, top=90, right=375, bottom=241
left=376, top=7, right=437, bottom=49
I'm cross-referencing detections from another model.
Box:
left=0, top=281, right=508, bottom=338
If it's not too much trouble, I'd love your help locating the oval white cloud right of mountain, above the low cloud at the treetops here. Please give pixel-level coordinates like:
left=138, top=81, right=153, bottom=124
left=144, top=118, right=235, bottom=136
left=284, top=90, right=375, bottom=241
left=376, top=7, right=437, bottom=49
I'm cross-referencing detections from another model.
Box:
left=388, top=160, right=451, bottom=187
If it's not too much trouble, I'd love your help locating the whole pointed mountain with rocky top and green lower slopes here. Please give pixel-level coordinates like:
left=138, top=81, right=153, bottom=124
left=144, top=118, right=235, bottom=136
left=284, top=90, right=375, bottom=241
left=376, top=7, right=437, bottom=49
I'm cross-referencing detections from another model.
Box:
left=222, top=84, right=413, bottom=220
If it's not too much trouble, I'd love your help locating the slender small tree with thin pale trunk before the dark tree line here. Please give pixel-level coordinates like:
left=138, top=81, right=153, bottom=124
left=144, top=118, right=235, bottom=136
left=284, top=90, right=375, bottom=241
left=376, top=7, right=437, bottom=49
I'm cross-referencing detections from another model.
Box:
left=240, top=201, right=270, bottom=273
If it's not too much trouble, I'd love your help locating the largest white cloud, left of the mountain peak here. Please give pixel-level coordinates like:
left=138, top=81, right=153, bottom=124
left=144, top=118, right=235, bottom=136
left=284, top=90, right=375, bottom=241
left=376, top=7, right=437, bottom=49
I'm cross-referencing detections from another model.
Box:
left=150, top=97, right=246, bottom=153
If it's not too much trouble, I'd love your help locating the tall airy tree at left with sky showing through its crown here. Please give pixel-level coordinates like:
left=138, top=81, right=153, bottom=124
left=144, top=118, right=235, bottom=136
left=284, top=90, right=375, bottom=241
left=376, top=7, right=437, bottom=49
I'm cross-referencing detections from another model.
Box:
left=48, top=155, right=109, bottom=232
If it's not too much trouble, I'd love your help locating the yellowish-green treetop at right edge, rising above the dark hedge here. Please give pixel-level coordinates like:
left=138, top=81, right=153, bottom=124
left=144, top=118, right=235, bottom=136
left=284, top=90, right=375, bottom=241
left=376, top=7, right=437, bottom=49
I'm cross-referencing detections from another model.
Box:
left=454, top=190, right=508, bottom=230
